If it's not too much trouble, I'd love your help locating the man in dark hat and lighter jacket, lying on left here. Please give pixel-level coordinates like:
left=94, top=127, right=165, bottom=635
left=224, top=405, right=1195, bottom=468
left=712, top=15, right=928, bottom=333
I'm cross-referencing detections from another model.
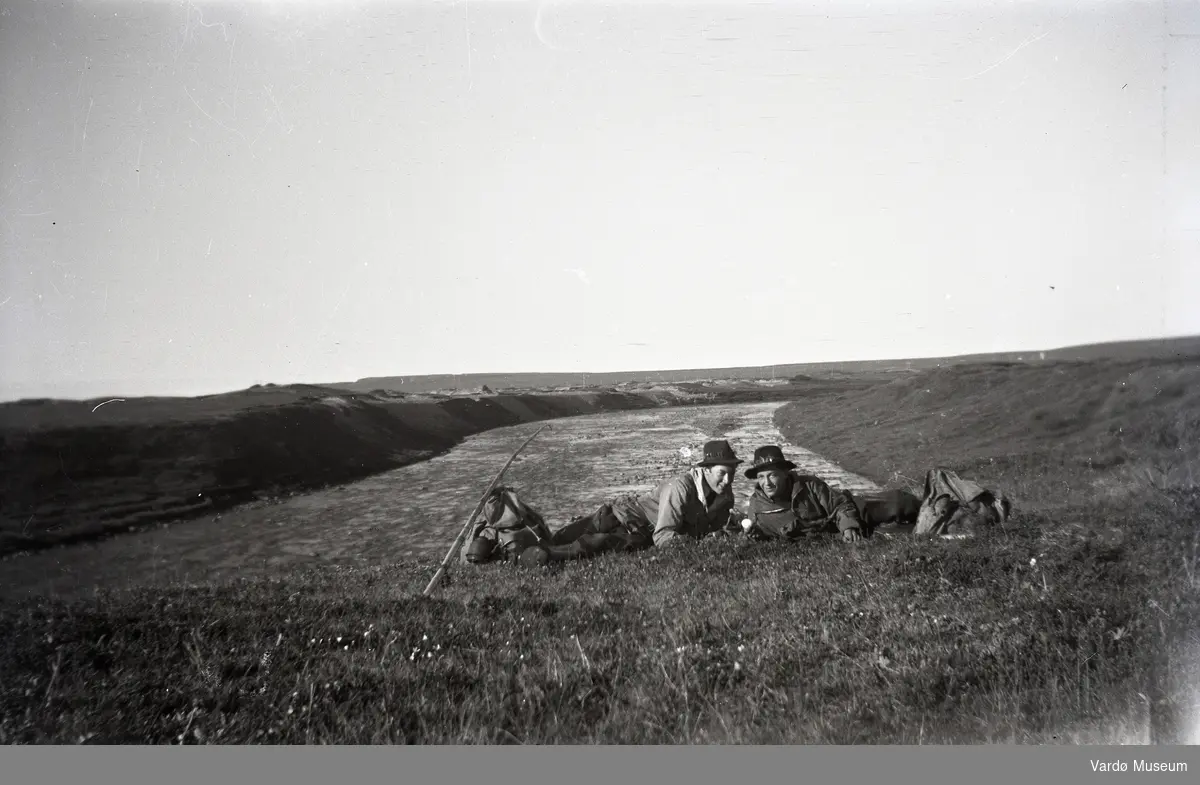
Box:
left=540, top=441, right=743, bottom=556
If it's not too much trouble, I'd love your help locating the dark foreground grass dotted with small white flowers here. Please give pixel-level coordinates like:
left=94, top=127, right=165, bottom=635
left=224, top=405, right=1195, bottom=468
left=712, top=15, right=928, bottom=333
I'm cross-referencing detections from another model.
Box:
left=0, top=493, right=1200, bottom=744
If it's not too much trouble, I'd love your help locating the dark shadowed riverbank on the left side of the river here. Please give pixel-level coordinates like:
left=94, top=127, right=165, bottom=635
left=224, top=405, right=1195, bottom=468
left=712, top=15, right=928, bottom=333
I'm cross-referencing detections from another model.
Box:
left=0, top=380, right=865, bottom=556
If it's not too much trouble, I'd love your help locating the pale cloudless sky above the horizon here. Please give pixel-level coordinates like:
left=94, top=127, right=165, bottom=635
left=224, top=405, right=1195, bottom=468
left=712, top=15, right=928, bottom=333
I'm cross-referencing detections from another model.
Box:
left=0, top=0, right=1200, bottom=400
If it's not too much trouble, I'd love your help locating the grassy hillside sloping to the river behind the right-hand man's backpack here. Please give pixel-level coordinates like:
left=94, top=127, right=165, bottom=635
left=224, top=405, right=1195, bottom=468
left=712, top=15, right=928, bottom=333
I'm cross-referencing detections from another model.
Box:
left=776, top=359, right=1200, bottom=509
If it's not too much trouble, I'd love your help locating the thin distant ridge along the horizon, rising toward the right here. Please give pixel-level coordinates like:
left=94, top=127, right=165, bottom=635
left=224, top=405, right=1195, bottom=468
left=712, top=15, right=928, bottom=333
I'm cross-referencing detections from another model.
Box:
left=322, top=336, right=1200, bottom=393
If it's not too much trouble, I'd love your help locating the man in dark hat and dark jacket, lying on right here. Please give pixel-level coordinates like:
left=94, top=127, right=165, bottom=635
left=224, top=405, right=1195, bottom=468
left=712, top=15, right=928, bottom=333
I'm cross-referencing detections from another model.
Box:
left=742, top=444, right=865, bottom=543
